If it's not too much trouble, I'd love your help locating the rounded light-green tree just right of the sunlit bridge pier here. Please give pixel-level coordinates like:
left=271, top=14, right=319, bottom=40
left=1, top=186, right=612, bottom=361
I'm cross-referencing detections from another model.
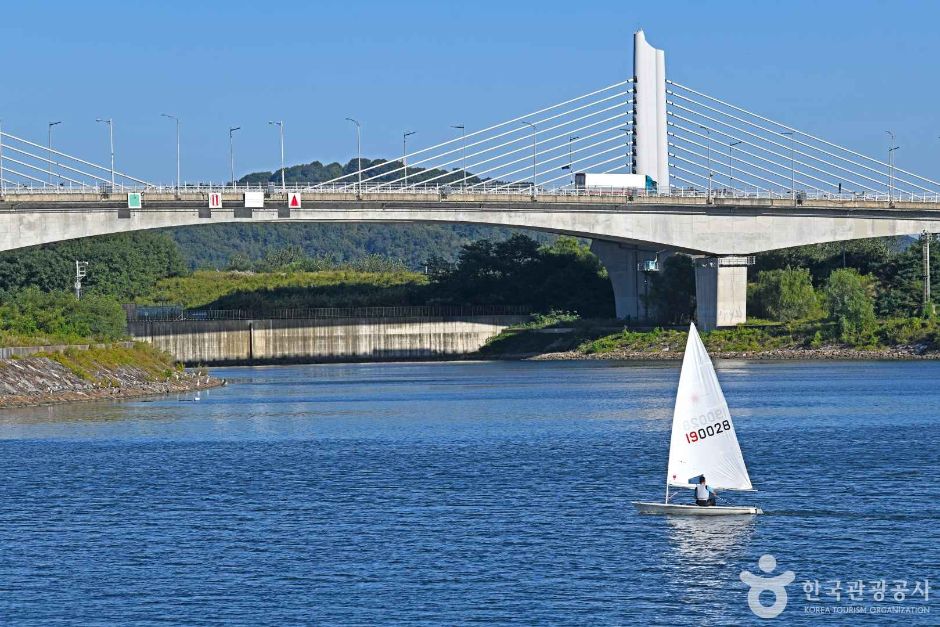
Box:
left=749, top=268, right=820, bottom=322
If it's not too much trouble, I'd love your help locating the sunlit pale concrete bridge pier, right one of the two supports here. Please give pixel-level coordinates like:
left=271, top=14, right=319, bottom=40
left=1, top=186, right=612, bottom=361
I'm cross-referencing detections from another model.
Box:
left=695, top=257, right=753, bottom=331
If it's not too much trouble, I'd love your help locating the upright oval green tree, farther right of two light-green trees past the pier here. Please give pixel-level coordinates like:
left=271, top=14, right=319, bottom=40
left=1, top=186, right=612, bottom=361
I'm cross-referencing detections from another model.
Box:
left=826, top=268, right=877, bottom=346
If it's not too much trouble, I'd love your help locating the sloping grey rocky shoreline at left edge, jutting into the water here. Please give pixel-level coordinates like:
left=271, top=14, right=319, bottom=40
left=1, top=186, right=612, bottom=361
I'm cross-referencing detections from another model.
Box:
left=0, top=357, right=225, bottom=409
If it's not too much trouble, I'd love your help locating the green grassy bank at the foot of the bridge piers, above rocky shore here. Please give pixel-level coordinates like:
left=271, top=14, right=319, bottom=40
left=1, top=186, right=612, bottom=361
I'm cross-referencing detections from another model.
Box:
left=481, top=316, right=940, bottom=358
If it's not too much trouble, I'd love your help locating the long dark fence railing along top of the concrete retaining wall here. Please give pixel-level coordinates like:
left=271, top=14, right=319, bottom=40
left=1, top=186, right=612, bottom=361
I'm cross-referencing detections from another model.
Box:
left=125, top=305, right=532, bottom=322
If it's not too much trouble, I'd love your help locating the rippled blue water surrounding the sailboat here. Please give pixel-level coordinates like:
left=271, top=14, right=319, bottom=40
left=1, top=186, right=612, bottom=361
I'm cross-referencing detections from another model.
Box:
left=0, top=362, right=940, bottom=625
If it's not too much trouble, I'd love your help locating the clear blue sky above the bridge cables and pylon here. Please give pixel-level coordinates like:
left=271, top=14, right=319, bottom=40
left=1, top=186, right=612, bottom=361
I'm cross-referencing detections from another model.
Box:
left=0, top=0, right=940, bottom=183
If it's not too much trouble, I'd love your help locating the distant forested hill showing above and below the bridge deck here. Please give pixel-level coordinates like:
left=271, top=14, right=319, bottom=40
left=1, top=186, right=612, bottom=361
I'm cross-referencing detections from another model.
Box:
left=169, top=159, right=555, bottom=270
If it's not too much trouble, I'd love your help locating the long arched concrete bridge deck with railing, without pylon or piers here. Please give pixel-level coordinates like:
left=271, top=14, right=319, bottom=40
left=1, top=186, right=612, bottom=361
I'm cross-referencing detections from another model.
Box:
left=0, top=191, right=940, bottom=255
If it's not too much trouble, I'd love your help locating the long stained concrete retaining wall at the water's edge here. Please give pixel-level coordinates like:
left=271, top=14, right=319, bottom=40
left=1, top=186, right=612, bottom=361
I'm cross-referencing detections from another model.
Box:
left=128, top=316, right=526, bottom=365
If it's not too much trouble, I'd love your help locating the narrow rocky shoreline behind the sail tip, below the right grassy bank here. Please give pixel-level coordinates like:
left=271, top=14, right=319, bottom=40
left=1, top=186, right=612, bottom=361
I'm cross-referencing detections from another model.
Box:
left=528, top=346, right=940, bottom=361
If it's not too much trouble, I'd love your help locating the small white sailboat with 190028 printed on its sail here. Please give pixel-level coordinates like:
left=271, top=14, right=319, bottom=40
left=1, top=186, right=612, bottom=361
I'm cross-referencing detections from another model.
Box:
left=633, top=324, right=763, bottom=516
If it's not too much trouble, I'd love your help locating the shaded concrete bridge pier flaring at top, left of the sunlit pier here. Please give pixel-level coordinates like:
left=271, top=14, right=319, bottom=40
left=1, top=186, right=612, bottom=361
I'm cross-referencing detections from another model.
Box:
left=591, top=239, right=656, bottom=322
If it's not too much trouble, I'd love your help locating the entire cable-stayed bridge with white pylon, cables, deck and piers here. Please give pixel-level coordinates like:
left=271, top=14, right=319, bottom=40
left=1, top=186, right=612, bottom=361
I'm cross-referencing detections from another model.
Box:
left=0, top=31, right=940, bottom=329
